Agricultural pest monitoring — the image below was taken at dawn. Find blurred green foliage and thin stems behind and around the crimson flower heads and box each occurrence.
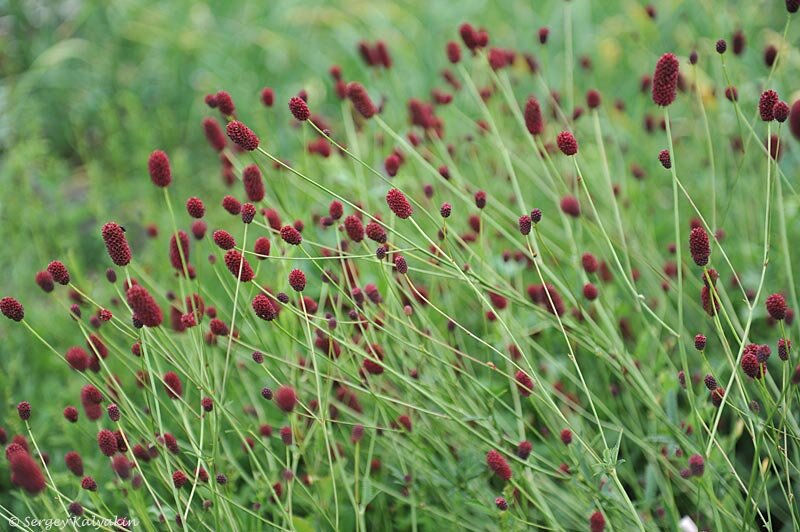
[0,0,800,531]
